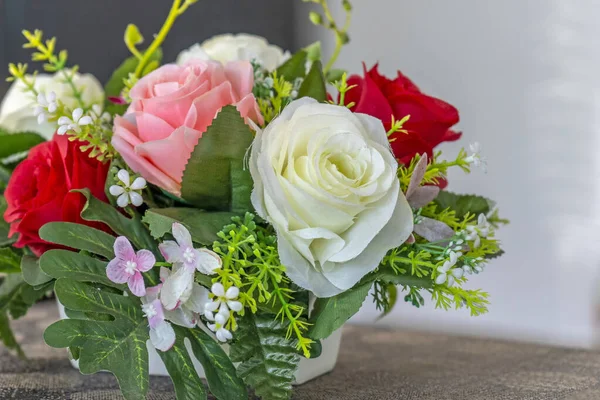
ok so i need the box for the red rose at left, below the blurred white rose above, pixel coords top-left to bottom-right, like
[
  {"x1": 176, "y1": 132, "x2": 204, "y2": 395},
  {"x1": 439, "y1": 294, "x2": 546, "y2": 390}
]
[{"x1": 4, "y1": 135, "x2": 109, "y2": 256}]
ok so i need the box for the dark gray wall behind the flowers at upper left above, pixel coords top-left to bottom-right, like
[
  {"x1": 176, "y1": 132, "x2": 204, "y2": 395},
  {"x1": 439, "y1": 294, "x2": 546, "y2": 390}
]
[{"x1": 0, "y1": 0, "x2": 299, "y2": 98}]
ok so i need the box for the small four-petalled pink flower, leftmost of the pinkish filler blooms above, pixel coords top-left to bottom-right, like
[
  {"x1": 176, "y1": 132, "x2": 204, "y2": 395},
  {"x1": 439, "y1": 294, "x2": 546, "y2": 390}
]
[{"x1": 106, "y1": 236, "x2": 156, "y2": 297}]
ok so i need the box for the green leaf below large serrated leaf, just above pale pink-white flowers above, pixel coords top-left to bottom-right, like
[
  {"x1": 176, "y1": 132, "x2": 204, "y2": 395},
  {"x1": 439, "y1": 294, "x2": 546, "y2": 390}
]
[{"x1": 143, "y1": 207, "x2": 238, "y2": 246}]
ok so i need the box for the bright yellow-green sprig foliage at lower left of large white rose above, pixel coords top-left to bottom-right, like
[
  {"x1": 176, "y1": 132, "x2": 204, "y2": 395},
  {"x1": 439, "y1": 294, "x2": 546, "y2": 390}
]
[{"x1": 213, "y1": 213, "x2": 313, "y2": 358}]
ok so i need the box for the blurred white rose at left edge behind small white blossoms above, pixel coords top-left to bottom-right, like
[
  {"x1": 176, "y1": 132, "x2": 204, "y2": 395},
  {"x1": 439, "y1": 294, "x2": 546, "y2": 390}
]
[{"x1": 0, "y1": 73, "x2": 104, "y2": 139}]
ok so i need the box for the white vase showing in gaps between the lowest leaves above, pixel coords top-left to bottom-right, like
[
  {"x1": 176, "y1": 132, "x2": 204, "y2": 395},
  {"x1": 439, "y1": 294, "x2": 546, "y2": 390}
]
[{"x1": 58, "y1": 303, "x2": 342, "y2": 385}]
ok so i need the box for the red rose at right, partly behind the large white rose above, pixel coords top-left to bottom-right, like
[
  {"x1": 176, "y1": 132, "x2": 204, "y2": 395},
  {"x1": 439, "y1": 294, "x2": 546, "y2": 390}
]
[{"x1": 346, "y1": 65, "x2": 461, "y2": 164}]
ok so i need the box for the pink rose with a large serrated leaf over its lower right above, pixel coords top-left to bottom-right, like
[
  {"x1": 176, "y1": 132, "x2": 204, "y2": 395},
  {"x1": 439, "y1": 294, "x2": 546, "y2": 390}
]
[{"x1": 112, "y1": 61, "x2": 263, "y2": 195}]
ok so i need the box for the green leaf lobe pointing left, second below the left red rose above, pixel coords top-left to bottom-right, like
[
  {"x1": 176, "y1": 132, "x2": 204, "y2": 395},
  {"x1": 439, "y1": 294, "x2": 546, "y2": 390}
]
[{"x1": 39, "y1": 250, "x2": 125, "y2": 291}]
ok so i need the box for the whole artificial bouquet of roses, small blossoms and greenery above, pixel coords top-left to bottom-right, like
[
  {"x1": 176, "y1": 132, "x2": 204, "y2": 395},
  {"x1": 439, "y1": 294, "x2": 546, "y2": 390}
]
[{"x1": 0, "y1": 0, "x2": 506, "y2": 400}]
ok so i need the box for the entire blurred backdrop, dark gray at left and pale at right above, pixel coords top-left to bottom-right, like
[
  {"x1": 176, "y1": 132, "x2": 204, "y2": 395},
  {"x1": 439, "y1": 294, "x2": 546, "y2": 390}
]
[{"x1": 0, "y1": 0, "x2": 600, "y2": 347}]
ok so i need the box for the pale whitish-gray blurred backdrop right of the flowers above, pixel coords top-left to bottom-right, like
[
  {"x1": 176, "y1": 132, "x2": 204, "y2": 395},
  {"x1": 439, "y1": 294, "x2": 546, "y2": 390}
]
[{"x1": 298, "y1": 0, "x2": 600, "y2": 347}]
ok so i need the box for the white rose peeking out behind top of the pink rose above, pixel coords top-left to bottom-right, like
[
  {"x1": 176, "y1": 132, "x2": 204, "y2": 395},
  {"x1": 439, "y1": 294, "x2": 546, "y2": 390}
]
[{"x1": 177, "y1": 34, "x2": 290, "y2": 71}]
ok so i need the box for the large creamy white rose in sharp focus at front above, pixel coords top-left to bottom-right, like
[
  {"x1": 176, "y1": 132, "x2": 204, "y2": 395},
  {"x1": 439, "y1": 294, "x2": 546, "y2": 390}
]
[{"x1": 250, "y1": 98, "x2": 413, "y2": 297}]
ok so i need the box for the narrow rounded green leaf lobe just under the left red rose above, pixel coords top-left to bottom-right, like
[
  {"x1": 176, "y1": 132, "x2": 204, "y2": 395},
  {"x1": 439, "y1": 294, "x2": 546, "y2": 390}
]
[{"x1": 40, "y1": 222, "x2": 115, "y2": 260}]
